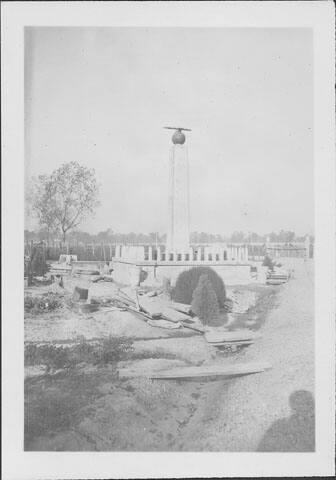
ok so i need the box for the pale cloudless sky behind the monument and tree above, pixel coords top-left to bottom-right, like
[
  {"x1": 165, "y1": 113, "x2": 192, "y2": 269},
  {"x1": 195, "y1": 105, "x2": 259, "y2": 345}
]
[{"x1": 25, "y1": 27, "x2": 314, "y2": 235}]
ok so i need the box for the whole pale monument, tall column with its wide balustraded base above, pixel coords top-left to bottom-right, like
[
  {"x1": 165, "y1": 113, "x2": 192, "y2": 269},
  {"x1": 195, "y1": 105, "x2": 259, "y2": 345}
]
[{"x1": 111, "y1": 127, "x2": 252, "y2": 286}]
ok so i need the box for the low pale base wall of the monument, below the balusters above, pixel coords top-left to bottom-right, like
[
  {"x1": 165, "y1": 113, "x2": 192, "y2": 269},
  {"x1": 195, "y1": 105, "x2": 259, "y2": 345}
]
[{"x1": 112, "y1": 260, "x2": 263, "y2": 286}]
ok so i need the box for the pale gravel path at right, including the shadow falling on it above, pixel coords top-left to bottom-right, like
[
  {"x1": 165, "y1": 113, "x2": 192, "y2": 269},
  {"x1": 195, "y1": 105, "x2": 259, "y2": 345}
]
[{"x1": 184, "y1": 262, "x2": 314, "y2": 451}]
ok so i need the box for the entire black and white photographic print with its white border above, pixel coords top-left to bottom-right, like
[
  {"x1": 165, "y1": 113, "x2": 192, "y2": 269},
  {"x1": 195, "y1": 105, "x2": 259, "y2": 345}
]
[{"x1": 3, "y1": 2, "x2": 335, "y2": 479}]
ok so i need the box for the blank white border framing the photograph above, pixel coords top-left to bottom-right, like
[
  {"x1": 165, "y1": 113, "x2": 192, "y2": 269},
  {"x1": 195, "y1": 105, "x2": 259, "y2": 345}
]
[{"x1": 1, "y1": 1, "x2": 336, "y2": 480}]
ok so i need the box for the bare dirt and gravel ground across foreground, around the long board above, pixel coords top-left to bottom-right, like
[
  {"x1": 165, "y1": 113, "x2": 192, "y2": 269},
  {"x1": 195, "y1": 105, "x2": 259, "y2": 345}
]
[{"x1": 25, "y1": 264, "x2": 314, "y2": 451}]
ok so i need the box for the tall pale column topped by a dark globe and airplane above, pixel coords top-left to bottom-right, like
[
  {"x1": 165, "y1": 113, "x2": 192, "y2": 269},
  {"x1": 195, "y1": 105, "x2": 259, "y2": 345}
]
[{"x1": 164, "y1": 127, "x2": 191, "y2": 253}]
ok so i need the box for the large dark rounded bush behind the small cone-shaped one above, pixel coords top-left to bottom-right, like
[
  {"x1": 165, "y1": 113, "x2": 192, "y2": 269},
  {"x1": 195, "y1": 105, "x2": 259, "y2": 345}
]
[{"x1": 172, "y1": 267, "x2": 226, "y2": 307}]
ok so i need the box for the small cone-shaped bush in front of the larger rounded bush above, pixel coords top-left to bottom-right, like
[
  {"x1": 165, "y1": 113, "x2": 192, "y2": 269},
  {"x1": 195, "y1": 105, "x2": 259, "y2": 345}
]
[{"x1": 191, "y1": 275, "x2": 219, "y2": 325}]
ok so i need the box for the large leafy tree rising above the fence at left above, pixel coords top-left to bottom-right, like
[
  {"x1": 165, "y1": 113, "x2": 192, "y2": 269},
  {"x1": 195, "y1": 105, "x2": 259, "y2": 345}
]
[{"x1": 33, "y1": 162, "x2": 99, "y2": 241}]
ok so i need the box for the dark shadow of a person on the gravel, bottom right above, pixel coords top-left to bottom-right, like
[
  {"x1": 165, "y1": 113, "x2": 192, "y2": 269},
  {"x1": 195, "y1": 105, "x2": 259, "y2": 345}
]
[{"x1": 257, "y1": 390, "x2": 315, "y2": 452}]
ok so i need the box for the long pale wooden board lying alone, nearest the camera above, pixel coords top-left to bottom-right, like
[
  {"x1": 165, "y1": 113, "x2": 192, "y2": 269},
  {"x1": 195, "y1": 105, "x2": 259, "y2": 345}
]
[{"x1": 119, "y1": 363, "x2": 272, "y2": 380}]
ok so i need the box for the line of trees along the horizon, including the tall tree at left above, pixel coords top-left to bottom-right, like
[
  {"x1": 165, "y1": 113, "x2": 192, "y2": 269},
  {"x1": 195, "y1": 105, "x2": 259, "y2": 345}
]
[{"x1": 25, "y1": 161, "x2": 313, "y2": 244}]
